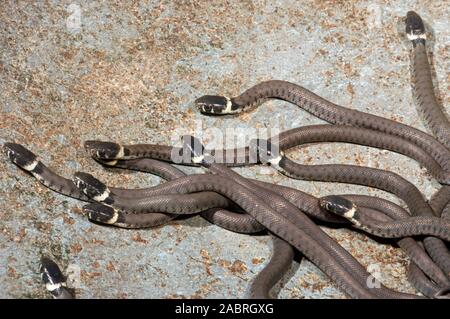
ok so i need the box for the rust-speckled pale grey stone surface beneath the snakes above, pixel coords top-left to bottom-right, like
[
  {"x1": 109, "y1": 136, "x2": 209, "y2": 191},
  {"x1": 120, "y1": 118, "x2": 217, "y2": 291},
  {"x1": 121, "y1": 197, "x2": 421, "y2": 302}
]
[{"x1": 0, "y1": 0, "x2": 450, "y2": 298}]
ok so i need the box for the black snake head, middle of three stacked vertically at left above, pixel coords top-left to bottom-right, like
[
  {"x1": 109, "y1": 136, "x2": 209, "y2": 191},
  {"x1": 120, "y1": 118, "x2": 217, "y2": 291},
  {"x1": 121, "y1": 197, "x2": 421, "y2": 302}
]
[{"x1": 73, "y1": 172, "x2": 114, "y2": 205}]
